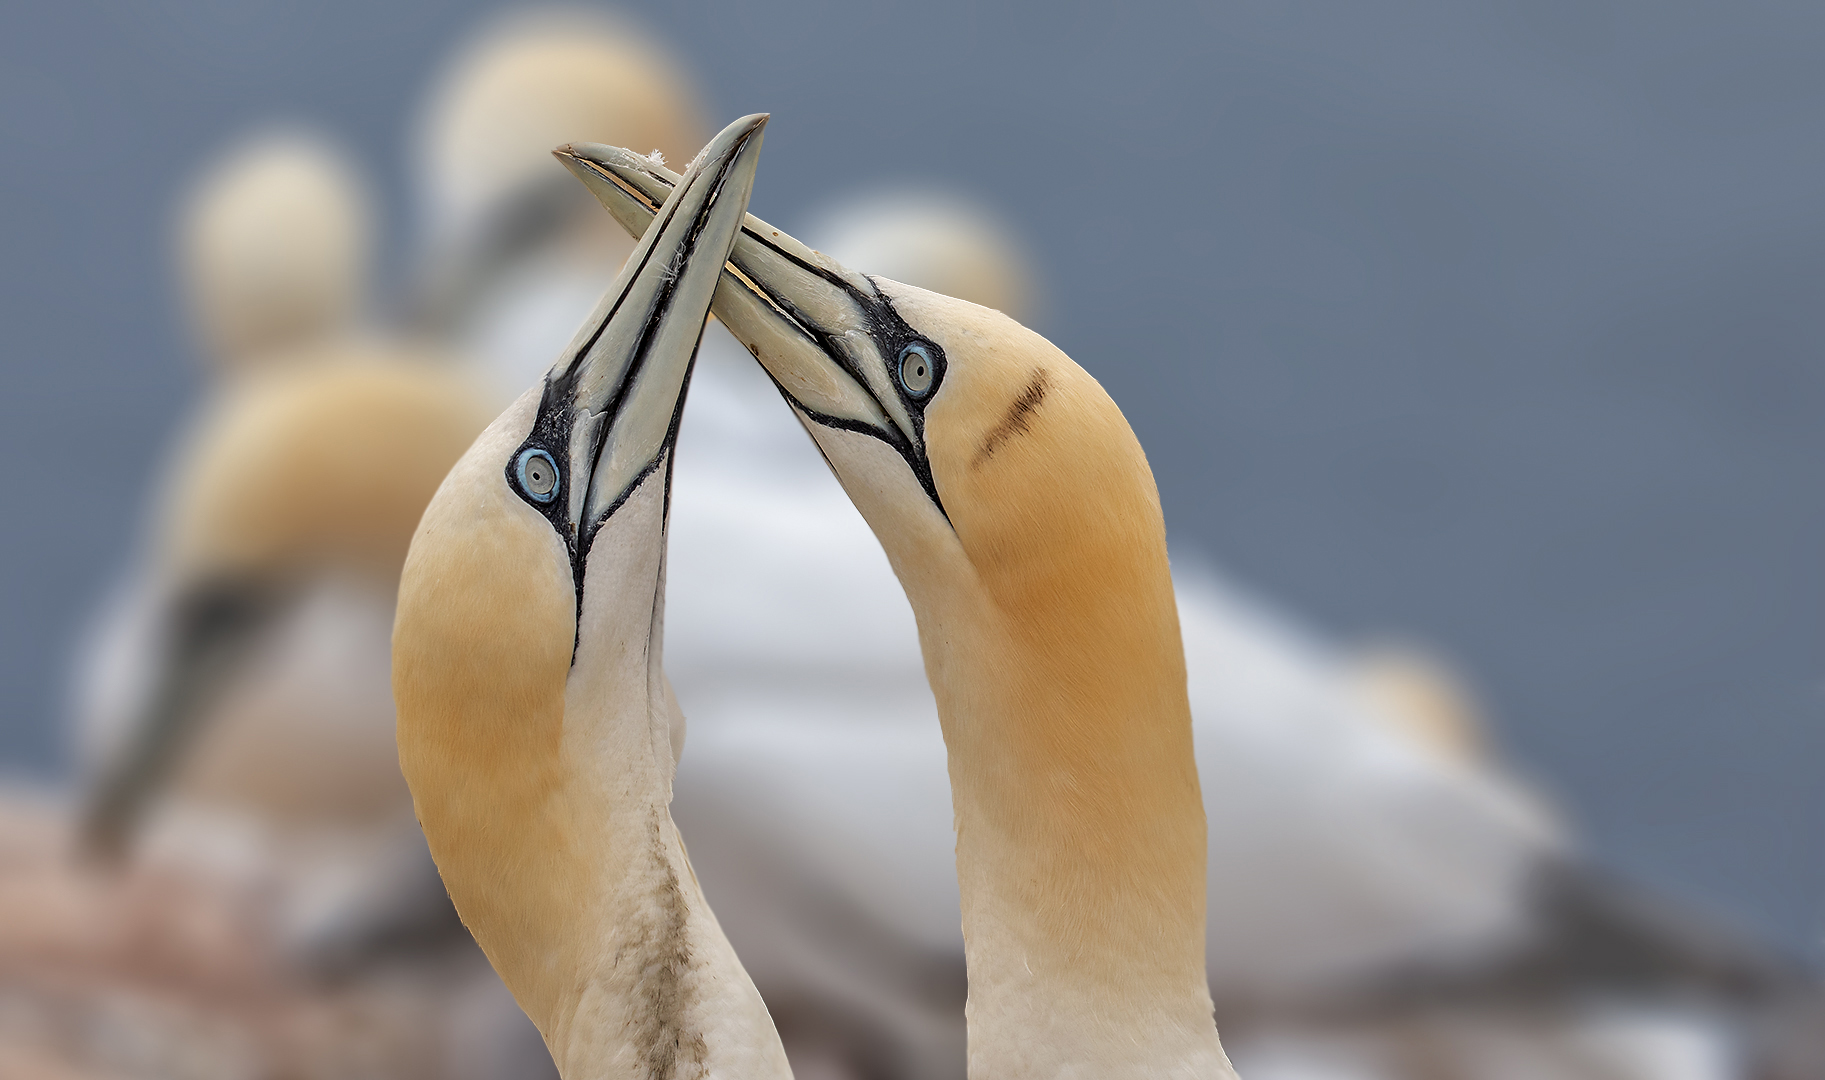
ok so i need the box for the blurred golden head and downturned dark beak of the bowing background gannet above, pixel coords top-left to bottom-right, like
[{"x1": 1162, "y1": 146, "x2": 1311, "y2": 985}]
[{"x1": 84, "y1": 348, "x2": 487, "y2": 854}]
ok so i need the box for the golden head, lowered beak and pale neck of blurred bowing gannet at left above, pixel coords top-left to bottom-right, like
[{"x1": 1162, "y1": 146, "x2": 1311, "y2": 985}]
[{"x1": 88, "y1": 356, "x2": 485, "y2": 868}]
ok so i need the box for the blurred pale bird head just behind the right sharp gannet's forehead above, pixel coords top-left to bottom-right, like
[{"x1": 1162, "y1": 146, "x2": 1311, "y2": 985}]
[{"x1": 801, "y1": 190, "x2": 1035, "y2": 323}]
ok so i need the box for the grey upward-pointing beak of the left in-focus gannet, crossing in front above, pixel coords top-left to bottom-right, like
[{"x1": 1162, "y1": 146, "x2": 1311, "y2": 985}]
[{"x1": 532, "y1": 113, "x2": 767, "y2": 561}]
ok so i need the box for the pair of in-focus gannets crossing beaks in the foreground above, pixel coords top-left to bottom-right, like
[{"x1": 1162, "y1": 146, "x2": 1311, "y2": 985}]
[{"x1": 394, "y1": 117, "x2": 1234, "y2": 1076}]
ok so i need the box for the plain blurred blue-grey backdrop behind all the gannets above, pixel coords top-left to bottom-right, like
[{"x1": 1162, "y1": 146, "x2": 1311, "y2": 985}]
[{"x1": 0, "y1": 0, "x2": 1825, "y2": 950}]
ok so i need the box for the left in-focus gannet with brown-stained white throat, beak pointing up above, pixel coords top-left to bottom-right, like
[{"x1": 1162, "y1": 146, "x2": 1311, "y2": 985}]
[{"x1": 394, "y1": 115, "x2": 790, "y2": 1078}]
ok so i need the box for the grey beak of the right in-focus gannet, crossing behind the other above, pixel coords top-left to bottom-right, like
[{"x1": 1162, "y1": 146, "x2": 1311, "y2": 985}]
[{"x1": 557, "y1": 142, "x2": 942, "y2": 502}]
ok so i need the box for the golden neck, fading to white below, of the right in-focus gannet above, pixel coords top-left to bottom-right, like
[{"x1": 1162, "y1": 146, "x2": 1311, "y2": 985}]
[{"x1": 916, "y1": 538, "x2": 1234, "y2": 1080}]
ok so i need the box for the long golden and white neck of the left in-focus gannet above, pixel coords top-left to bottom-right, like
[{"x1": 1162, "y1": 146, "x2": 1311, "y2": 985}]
[{"x1": 394, "y1": 481, "x2": 790, "y2": 1080}]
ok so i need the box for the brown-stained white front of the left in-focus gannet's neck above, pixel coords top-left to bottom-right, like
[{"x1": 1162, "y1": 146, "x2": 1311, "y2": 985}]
[{"x1": 546, "y1": 474, "x2": 790, "y2": 1080}]
